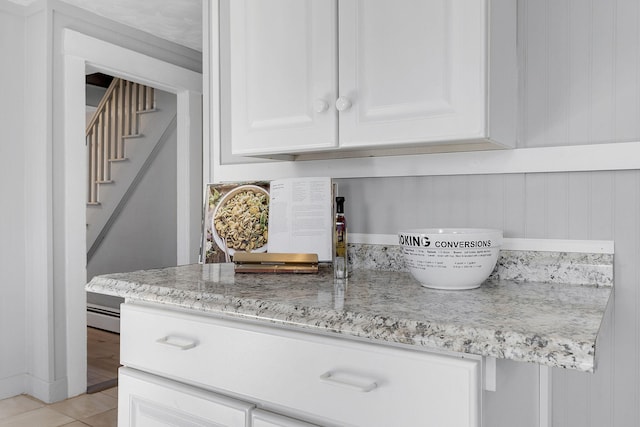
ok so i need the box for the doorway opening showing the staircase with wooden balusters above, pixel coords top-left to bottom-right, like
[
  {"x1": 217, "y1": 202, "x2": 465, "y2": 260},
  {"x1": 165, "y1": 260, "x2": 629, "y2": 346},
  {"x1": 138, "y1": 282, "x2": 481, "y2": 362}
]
[{"x1": 85, "y1": 73, "x2": 177, "y2": 392}]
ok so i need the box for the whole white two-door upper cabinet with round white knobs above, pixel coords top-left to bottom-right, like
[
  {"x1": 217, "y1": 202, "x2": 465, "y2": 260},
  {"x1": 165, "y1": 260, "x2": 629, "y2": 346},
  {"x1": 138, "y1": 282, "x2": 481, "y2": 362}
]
[{"x1": 221, "y1": 0, "x2": 517, "y2": 159}]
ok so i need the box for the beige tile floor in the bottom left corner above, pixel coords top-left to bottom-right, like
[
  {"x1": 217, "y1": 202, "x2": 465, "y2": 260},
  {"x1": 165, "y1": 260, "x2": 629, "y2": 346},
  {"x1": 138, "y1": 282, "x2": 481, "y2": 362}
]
[{"x1": 0, "y1": 387, "x2": 118, "y2": 427}]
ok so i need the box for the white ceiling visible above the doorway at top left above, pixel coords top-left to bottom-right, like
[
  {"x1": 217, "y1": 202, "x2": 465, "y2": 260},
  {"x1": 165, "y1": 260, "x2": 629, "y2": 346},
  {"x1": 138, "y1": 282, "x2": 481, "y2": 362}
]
[{"x1": 5, "y1": 0, "x2": 203, "y2": 52}]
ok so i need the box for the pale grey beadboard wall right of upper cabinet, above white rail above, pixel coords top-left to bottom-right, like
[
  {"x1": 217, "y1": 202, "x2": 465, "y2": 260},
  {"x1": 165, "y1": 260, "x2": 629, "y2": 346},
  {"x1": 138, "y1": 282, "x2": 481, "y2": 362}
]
[{"x1": 518, "y1": 0, "x2": 640, "y2": 147}]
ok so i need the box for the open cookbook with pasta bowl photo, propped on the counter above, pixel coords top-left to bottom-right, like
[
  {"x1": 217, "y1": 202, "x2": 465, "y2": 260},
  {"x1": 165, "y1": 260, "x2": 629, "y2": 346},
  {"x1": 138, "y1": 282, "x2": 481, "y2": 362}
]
[{"x1": 202, "y1": 177, "x2": 335, "y2": 263}]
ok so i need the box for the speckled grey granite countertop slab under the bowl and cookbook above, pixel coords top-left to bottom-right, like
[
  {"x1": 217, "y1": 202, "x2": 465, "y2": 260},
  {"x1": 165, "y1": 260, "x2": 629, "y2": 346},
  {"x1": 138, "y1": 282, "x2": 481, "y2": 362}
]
[{"x1": 86, "y1": 249, "x2": 613, "y2": 372}]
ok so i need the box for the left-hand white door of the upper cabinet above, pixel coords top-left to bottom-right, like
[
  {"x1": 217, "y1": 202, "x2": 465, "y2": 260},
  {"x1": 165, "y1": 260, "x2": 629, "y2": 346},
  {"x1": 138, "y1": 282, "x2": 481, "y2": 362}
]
[{"x1": 229, "y1": 0, "x2": 338, "y2": 155}]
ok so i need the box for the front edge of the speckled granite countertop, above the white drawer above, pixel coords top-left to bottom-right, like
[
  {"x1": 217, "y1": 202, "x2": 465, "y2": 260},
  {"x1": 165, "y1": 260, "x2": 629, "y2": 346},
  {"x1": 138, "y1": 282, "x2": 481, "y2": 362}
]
[{"x1": 87, "y1": 276, "x2": 608, "y2": 372}]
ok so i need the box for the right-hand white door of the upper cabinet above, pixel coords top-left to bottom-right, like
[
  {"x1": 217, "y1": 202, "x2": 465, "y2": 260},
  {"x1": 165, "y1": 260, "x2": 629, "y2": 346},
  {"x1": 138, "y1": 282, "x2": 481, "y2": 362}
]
[{"x1": 338, "y1": 0, "x2": 487, "y2": 148}]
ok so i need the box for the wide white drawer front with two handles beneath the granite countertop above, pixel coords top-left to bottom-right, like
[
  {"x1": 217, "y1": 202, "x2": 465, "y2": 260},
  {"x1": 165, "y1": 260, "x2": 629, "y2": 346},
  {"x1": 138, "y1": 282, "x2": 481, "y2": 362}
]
[{"x1": 120, "y1": 304, "x2": 480, "y2": 427}]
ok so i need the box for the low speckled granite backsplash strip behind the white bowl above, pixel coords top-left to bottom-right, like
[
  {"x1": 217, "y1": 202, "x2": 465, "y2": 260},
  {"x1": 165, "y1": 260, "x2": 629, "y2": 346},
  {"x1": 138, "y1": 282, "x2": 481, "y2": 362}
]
[{"x1": 349, "y1": 244, "x2": 613, "y2": 287}]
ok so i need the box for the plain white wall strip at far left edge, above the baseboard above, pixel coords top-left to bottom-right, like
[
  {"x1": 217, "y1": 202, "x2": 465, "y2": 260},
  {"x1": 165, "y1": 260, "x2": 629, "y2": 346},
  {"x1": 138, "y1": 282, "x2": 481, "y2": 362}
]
[{"x1": 0, "y1": 3, "x2": 27, "y2": 399}]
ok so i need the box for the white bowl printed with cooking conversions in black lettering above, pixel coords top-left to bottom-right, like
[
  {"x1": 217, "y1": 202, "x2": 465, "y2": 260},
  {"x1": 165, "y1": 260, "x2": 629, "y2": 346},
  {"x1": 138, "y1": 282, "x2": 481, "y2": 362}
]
[{"x1": 398, "y1": 228, "x2": 502, "y2": 289}]
